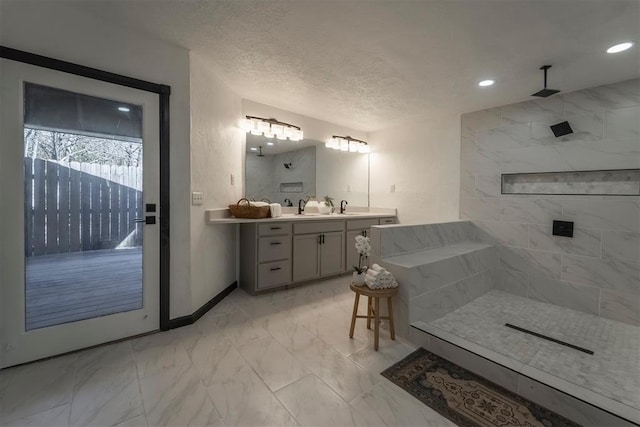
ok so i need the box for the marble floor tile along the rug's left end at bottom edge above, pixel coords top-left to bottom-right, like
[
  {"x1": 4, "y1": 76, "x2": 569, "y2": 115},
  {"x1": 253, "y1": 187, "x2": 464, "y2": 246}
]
[{"x1": 351, "y1": 379, "x2": 456, "y2": 427}]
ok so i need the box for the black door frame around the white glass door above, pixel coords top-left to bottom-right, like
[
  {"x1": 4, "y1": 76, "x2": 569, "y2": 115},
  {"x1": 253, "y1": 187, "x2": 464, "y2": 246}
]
[{"x1": 0, "y1": 46, "x2": 171, "y2": 331}]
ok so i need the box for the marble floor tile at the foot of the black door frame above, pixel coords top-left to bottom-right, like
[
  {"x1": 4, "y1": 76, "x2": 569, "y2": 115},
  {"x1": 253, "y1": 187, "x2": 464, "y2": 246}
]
[{"x1": 132, "y1": 329, "x2": 191, "y2": 378}]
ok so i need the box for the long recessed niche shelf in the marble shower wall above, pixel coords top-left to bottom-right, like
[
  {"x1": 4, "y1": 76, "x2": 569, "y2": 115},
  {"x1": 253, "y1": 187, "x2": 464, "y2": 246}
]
[{"x1": 501, "y1": 169, "x2": 640, "y2": 196}]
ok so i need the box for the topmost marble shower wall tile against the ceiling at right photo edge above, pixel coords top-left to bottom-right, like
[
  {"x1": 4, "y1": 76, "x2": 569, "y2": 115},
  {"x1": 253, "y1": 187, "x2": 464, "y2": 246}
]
[{"x1": 564, "y1": 79, "x2": 640, "y2": 115}]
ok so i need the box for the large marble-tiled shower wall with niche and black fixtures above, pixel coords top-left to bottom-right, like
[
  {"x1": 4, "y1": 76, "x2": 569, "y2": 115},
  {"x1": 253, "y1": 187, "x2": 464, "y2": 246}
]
[{"x1": 460, "y1": 79, "x2": 640, "y2": 325}]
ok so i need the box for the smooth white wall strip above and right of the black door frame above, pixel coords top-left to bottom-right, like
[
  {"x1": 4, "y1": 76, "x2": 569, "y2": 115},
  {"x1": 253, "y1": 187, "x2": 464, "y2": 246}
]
[{"x1": 0, "y1": 2, "x2": 192, "y2": 318}]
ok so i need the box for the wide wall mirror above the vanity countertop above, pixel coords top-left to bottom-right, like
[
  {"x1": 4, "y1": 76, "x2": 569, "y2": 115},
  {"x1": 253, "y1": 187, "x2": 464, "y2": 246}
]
[{"x1": 245, "y1": 134, "x2": 369, "y2": 206}]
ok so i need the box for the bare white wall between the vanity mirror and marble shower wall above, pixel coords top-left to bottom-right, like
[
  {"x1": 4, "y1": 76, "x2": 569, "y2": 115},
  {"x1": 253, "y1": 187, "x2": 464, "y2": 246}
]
[{"x1": 369, "y1": 114, "x2": 460, "y2": 224}]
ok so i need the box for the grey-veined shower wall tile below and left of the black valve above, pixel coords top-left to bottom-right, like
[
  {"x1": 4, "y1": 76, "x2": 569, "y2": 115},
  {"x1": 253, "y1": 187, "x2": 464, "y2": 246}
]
[{"x1": 499, "y1": 246, "x2": 560, "y2": 278}]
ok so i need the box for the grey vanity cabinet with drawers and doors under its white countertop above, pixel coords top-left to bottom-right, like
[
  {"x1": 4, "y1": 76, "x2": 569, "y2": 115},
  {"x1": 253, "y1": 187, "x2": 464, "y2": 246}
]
[{"x1": 232, "y1": 213, "x2": 396, "y2": 295}]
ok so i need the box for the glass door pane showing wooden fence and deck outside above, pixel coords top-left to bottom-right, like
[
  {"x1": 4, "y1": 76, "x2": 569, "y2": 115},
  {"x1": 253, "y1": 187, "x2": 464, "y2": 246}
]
[{"x1": 24, "y1": 83, "x2": 143, "y2": 330}]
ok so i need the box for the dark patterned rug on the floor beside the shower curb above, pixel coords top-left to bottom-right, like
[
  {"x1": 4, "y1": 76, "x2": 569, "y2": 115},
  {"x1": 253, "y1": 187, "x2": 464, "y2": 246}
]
[{"x1": 382, "y1": 348, "x2": 578, "y2": 427}]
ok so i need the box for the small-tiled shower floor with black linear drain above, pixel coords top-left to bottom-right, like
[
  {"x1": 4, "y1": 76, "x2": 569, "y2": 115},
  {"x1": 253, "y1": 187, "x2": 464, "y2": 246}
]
[{"x1": 429, "y1": 290, "x2": 640, "y2": 418}]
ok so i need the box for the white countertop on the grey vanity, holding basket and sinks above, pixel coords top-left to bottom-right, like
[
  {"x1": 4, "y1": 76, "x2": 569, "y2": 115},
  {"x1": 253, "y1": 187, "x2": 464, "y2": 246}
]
[{"x1": 205, "y1": 208, "x2": 396, "y2": 224}]
